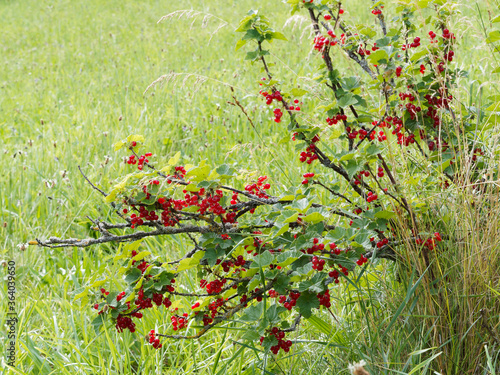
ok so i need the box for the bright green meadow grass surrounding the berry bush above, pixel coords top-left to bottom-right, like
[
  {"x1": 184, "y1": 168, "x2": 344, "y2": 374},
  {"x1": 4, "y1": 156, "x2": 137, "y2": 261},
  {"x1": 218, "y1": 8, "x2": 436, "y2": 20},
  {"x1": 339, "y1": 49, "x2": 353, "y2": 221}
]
[{"x1": 0, "y1": 0, "x2": 499, "y2": 374}]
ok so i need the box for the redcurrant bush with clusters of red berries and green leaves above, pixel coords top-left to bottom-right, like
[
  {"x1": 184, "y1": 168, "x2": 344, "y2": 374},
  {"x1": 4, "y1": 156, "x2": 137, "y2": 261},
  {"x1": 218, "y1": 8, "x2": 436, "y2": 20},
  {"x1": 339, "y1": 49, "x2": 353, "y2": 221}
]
[{"x1": 38, "y1": 0, "x2": 496, "y2": 368}]
